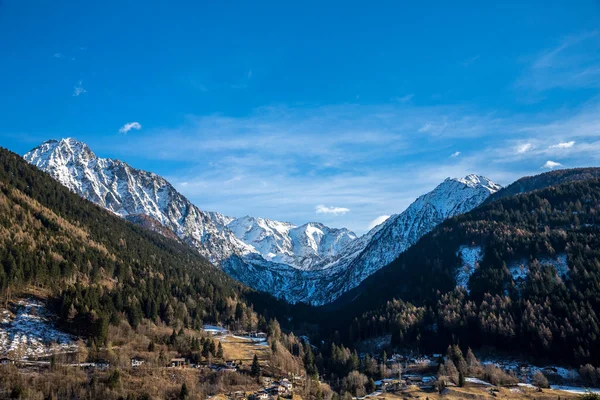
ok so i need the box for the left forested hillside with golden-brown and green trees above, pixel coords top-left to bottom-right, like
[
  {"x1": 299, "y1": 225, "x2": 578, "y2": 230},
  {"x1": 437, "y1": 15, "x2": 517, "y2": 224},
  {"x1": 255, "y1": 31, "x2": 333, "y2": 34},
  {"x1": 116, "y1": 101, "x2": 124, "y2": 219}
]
[{"x1": 0, "y1": 149, "x2": 271, "y2": 342}]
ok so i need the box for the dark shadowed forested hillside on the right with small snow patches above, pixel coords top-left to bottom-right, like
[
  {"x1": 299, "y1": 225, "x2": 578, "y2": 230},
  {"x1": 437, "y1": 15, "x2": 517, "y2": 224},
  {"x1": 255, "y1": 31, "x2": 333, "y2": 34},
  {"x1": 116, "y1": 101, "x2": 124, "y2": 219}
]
[{"x1": 327, "y1": 177, "x2": 600, "y2": 365}]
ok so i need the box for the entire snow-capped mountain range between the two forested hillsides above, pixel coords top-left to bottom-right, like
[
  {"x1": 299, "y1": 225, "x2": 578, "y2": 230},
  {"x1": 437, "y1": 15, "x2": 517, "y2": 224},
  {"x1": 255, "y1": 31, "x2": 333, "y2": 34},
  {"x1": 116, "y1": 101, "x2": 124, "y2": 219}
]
[{"x1": 24, "y1": 138, "x2": 501, "y2": 305}]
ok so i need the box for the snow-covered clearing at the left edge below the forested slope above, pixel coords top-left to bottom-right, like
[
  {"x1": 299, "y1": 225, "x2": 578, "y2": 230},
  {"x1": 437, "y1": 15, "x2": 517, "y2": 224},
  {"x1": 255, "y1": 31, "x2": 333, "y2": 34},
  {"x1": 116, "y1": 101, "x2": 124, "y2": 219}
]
[{"x1": 0, "y1": 299, "x2": 77, "y2": 359}]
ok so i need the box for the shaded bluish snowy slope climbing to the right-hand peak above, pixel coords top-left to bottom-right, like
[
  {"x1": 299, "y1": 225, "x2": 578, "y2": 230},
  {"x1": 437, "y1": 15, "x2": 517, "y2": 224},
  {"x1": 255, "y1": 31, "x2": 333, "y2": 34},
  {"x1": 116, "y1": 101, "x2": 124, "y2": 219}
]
[{"x1": 220, "y1": 175, "x2": 501, "y2": 305}]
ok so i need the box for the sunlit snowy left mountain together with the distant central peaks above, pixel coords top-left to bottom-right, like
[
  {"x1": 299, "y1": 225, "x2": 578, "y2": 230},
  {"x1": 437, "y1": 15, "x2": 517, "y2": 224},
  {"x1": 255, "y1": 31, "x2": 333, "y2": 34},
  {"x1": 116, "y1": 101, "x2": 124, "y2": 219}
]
[{"x1": 24, "y1": 138, "x2": 356, "y2": 269}]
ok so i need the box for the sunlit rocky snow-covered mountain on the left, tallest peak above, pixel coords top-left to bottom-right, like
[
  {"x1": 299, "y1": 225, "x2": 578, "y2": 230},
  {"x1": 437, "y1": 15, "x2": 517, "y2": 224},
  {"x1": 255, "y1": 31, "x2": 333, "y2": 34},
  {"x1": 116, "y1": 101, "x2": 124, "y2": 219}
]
[{"x1": 24, "y1": 138, "x2": 254, "y2": 263}]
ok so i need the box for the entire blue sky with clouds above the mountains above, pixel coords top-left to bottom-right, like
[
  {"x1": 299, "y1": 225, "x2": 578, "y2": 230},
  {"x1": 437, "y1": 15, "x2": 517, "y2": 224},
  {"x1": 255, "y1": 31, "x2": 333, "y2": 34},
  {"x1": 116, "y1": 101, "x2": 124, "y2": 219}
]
[{"x1": 0, "y1": 0, "x2": 600, "y2": 233}]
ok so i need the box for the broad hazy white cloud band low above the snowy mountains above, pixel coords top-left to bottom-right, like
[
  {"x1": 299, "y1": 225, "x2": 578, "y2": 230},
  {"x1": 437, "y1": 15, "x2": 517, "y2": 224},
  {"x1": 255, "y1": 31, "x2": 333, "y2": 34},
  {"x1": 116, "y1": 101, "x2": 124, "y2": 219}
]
[{"x1": 101, "y1": 104, "x2": 600, "y2": 234}]
